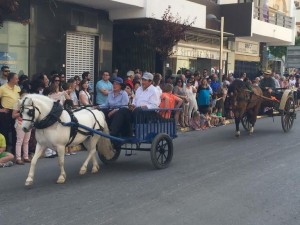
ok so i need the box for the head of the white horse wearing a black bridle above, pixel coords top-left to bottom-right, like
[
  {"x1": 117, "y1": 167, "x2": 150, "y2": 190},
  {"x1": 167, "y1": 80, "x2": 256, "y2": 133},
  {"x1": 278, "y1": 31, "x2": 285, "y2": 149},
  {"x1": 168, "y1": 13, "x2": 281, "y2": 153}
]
[{"x1": 19, "y1": 95, "x2": 41, "y2": 132}]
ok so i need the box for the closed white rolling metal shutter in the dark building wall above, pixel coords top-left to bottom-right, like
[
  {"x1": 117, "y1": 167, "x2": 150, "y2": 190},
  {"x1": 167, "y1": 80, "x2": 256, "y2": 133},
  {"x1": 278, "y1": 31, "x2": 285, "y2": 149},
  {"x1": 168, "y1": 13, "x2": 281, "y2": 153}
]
[{"x1": 66, "y1": 33, "x2": 95, "y2": 87}]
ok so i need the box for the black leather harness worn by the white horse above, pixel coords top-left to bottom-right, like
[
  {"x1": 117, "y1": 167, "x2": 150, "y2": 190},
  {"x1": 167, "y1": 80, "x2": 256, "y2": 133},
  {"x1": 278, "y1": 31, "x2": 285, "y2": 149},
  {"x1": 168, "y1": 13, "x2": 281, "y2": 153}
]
[{"x1": 20, "y1": 97, "x2": 104, "y2": 146}]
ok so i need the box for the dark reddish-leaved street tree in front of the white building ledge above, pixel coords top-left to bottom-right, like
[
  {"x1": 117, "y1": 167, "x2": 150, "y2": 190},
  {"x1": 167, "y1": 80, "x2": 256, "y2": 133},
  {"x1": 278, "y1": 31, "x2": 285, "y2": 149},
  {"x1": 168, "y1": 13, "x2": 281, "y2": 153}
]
[{"x1": 136, "y1": 5, "x2": 196, "y2": 69}]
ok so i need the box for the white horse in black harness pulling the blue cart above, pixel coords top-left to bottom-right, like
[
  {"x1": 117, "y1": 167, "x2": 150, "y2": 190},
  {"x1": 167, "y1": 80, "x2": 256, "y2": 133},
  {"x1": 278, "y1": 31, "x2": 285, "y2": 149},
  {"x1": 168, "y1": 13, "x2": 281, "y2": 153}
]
[{"x1": 19, "y1": 94, "x2": 114, "y2": 186}]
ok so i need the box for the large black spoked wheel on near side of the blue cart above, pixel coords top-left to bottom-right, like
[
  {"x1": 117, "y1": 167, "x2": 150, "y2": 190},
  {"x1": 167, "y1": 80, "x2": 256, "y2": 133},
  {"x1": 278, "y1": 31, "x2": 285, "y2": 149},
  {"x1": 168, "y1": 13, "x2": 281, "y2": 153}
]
[{"x1": 150, "y1": 134, "x2": 173, "y2": 169}]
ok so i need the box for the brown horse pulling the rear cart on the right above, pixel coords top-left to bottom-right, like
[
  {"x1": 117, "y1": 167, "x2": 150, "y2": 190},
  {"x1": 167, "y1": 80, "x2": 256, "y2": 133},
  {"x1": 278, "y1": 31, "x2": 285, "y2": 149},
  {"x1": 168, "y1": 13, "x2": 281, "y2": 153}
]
[{"x1": 228, "y1": 80, "x2": 263, "y2": 137}]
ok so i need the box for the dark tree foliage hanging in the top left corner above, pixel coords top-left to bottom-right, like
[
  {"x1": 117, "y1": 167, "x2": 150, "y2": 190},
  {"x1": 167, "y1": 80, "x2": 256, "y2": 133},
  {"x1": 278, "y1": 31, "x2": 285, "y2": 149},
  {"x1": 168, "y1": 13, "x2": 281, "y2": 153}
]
[{"x1": 0, "y1": 0, "x2": 30, "y2": 26}]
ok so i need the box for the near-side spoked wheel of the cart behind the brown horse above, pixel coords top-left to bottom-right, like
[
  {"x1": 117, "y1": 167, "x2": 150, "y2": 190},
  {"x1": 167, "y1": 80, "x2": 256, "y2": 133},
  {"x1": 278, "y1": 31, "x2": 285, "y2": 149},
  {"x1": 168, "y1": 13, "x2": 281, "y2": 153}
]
[{"x1": 281, "y1": 96, "x2": 296, "y2": 132}]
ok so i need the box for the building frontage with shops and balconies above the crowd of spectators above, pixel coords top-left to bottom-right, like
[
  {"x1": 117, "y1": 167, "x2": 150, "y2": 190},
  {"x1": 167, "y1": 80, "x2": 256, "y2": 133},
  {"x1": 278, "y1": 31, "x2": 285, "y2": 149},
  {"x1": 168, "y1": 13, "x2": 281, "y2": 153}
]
[{"x1": 0, "y1": 0, "x2": 296, "y2": 80}]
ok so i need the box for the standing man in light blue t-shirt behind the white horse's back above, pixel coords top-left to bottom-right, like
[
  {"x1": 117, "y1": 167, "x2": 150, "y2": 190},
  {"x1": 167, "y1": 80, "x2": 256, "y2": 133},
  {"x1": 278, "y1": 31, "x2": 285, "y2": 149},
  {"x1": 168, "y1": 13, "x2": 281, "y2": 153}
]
[{"x1": 96, "y1": 71, "x2": 112, "y2": 105}]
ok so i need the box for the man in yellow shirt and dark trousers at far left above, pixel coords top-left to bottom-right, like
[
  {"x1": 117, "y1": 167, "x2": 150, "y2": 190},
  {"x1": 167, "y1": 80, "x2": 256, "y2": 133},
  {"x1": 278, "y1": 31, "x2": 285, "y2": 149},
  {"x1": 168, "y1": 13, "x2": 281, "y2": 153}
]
[{"x1": 0, "y1": 73, "x2": 21, "y2": 154}]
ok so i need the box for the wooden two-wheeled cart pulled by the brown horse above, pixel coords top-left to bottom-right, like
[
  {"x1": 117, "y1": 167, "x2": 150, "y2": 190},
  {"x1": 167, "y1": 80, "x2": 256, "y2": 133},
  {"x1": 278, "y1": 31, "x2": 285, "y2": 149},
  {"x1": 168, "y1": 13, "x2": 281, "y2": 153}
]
[{"x1": 241, "y1": 88, "x2": 297, "y2": 132}]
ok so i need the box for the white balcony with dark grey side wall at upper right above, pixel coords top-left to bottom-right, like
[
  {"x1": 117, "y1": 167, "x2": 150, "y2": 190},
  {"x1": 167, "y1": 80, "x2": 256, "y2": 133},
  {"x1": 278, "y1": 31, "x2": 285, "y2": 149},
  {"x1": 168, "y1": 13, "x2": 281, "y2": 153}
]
[{"x1": 221, "y1": 2, "x2": 295, "y2": 46}]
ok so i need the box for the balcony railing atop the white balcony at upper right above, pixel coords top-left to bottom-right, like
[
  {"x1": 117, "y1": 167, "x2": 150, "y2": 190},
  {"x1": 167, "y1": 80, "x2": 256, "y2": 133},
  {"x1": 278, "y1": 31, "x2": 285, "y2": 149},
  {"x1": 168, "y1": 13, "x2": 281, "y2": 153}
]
[{"x1": 254, "y1": 7, "x2": 293, "y2": 29}]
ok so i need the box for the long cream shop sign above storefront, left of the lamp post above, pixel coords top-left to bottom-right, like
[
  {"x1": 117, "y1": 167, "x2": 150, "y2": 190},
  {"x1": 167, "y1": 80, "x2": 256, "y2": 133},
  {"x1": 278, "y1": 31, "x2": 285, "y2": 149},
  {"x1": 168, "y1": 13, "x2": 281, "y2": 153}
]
[{"x1": 174, "y1": 46, "x2": 227, "y2": 60}]
